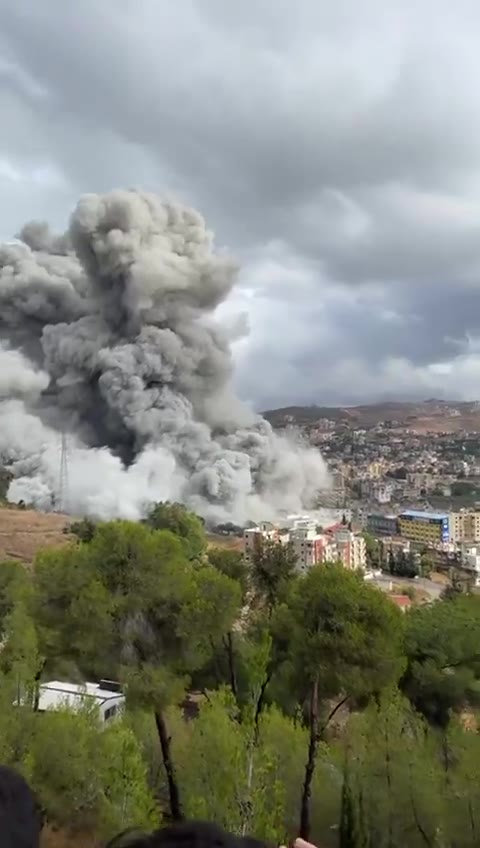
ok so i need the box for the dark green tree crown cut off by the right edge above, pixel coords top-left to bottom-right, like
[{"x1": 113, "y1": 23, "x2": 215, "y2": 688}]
[{"x1": 401, "y1": 595, "x2": 480, "y2": 727}]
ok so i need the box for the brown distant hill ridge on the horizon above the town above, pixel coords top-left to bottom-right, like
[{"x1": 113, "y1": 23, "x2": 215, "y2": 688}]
[{"x1": 263, "y1": 399, "x2": 480, "y2": 433}]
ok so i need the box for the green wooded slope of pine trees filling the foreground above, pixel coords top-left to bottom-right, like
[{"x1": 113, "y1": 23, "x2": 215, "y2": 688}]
[{"x1": 0, "y1": 504, "x2": 480, "y2": 848}]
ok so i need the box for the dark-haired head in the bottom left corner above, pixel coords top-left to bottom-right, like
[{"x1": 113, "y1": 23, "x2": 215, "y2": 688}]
[{"x1": 0, "y1": 766, "x2": 42, "y2": 848}]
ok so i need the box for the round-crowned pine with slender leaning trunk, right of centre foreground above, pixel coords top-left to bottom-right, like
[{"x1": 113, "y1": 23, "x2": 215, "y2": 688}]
[{"x1": 277, "y1": 565, "x2": 403, "y2": 839}]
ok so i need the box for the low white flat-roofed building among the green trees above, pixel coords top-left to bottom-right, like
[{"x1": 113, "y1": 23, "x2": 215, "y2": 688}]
[{"x1": 37, "y1": 680, "x2": 125, "y2": 724}]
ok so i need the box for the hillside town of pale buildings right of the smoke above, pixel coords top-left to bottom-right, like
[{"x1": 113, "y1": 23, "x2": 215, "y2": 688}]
[{"x1": 251, "y1": 401, "x2": 480, "y2": 596}]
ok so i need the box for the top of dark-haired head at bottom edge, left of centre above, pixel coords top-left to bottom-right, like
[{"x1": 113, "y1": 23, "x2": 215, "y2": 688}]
[{"x1": 107, "y1": 821, "x2": 267, "y2": 848}]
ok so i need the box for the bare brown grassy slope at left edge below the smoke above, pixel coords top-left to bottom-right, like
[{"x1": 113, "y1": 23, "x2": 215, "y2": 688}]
[{"x1": 0, "y1": 507, "x2": 73, "y2": 563}]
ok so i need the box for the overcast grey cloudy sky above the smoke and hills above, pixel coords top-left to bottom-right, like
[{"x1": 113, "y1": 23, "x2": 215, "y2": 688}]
[{"x1": 0, "y1": 0, "x2": 480, "y2": 408}]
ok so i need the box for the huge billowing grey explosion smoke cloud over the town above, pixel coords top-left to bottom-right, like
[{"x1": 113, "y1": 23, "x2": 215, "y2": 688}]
[{"x1": 0, "y1": 191, "x2": 327, "y2": 523}]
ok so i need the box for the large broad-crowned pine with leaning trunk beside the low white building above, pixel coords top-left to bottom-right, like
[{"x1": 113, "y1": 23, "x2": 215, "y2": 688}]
[{"x1": 35, "y1": 521, "x2": 241, "y2": 819}]
